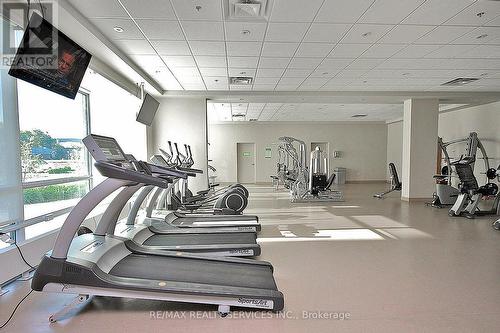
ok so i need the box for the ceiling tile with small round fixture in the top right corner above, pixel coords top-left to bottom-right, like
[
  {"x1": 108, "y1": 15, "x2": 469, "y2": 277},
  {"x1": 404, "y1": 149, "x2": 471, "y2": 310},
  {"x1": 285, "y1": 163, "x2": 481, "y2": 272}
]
[{"x1": 444, "y1": 1, "x2": 500, "y2": 26}]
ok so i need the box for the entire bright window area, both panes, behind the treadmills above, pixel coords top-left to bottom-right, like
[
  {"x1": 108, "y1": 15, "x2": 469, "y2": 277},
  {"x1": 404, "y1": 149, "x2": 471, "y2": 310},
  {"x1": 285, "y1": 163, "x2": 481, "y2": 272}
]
[{"x1": 12, "y1": 70, "x2": 147, "y2": 240}]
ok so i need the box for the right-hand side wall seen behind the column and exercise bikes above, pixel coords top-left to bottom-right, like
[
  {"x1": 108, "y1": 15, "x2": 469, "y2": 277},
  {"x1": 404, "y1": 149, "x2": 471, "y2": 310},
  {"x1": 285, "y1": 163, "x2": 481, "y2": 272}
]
[{"x1": 387, "y1": 102, "x2": 500, "y2": 183}]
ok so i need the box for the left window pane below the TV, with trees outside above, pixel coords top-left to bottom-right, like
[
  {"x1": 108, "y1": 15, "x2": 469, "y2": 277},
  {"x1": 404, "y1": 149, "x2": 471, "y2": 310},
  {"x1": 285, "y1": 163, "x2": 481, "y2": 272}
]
[{"x1": 17, "y1": 80, "x2": 91, "y2": 239}]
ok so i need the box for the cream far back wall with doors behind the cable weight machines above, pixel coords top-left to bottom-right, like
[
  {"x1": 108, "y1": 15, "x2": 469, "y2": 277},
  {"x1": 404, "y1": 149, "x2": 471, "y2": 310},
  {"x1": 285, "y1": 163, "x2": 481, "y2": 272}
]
[{"x1": 209, "y1": 122, "x2": 387, "y2": 182}]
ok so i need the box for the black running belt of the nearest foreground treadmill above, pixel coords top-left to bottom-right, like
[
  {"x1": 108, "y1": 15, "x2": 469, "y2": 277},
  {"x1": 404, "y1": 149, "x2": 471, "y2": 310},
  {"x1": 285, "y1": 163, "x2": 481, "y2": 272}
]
[{"x1": 109, "y1": 254, "x2": 277, "y2": 290}]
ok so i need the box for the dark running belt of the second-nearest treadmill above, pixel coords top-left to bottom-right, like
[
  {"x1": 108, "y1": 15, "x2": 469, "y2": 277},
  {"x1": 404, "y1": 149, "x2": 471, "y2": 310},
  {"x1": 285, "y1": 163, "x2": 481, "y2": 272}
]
[{"x1": 143, "y1": 232, "x2": 257, "y2": 246}]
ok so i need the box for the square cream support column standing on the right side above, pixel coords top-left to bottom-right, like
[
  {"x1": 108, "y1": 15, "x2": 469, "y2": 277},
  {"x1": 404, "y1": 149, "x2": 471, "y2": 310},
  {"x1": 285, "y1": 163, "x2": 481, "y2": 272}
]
[{"x1": 401, "y1": 99, "x2": 439, "y2": 201}]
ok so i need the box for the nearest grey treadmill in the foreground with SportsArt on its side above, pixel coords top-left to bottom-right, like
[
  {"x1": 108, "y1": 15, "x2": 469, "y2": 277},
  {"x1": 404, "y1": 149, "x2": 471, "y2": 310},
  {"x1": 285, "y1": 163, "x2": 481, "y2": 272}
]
[{"x1": 31, "y1": 133, "x2": 284, "y2": 322}]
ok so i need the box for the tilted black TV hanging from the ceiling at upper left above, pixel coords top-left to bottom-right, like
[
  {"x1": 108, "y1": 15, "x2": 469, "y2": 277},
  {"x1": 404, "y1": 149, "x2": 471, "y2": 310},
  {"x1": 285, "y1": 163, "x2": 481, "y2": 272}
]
[{"x1": 9, "y1": 13, "x2": 92, "y2": 99}]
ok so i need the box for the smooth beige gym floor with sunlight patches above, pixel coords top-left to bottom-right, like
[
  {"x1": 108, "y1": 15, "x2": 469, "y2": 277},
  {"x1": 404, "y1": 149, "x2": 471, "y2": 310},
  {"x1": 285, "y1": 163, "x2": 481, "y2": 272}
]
[{"x1": 0, "y1": 184, "x2": 500, "y2": 333}]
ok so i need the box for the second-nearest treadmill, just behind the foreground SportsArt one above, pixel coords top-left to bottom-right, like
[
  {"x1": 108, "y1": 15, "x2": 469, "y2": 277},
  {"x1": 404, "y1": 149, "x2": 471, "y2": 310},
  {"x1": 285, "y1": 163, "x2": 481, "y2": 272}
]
[{"x1": 83, "y1": 134, "x2": 261, "y2": 257}]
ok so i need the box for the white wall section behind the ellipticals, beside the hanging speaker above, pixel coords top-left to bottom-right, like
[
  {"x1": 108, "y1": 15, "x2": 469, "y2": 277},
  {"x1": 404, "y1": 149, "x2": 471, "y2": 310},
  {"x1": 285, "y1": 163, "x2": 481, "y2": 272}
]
[{"x1": 148, "y1": 97, "x2": 208, "y2": 190}]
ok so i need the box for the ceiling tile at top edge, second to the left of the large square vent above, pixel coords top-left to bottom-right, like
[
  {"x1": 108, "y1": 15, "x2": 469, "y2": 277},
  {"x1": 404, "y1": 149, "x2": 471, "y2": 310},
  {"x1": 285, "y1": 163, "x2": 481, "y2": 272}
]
[{"x1": 120, "y1": 0, "x2": 177, "y2": 21}]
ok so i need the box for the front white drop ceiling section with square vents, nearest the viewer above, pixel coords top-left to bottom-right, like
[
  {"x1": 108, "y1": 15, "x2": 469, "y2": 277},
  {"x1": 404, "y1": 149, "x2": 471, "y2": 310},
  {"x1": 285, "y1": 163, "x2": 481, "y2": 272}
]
[{"x1": 68, "y1": 0, "x2": 500, "y2": 92}]
